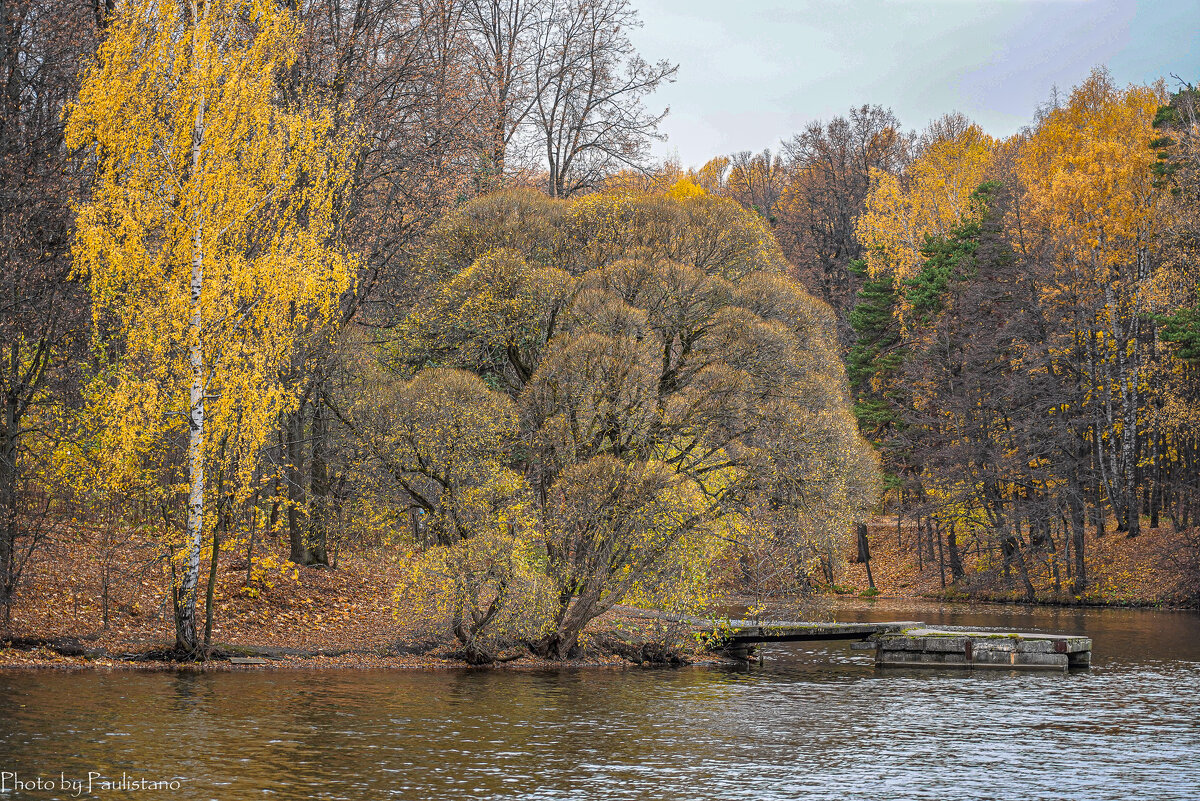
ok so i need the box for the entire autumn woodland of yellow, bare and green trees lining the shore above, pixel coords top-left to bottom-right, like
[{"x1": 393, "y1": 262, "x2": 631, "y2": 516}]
[{"x1": 0, "y1": 0, "x2": 1200, "y2": 663}]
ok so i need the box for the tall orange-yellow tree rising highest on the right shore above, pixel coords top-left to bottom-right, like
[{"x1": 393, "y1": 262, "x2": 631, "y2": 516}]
[{"x1": 1018, "y1": 71, "x2": 1165, "y2": 536}]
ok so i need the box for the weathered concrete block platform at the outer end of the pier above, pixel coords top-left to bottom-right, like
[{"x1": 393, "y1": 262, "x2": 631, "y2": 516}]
[{"x1": 871, "y1": 628, "x2": 1092, "y2": 670}]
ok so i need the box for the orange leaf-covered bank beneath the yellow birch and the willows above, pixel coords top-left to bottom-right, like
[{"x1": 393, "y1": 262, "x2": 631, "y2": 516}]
[{"x1": 0, "y1": 541, "x2": 719, "y2": 670}]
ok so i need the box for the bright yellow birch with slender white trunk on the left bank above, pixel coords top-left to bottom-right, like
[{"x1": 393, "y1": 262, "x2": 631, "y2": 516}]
[{"x1": 67, "y1": 0, "x2": 353, "y2": 652}]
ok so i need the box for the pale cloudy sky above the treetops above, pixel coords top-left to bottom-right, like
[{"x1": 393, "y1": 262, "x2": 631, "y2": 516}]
[{"x1": 630, "y1": 0, "x2": 1200, "y2": 167}]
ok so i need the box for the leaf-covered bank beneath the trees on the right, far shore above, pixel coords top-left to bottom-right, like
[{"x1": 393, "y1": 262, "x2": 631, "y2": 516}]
[{"x1": 836, "y1": 517, "x2": 1200, "y2": 609}]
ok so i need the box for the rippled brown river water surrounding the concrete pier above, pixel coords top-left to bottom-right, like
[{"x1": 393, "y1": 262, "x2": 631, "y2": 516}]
[{"x1": 0, "y1": 602, "x2": 1200, "y2": 801}]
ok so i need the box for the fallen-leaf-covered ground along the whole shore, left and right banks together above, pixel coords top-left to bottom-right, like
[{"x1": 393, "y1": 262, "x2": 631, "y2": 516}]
[{"x1": 0, "y1": 518, "x2": 1198, "y2": 670}]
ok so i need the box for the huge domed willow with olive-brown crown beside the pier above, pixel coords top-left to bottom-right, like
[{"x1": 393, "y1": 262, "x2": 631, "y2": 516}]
[{"x1": 350, "y1": 192, "x2": 877, "y2": 657}]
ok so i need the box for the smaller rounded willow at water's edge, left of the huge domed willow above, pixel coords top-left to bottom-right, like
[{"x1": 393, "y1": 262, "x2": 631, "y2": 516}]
[{"x1": 337, "y1": 368, "x2": 546, "y2": 664}]
